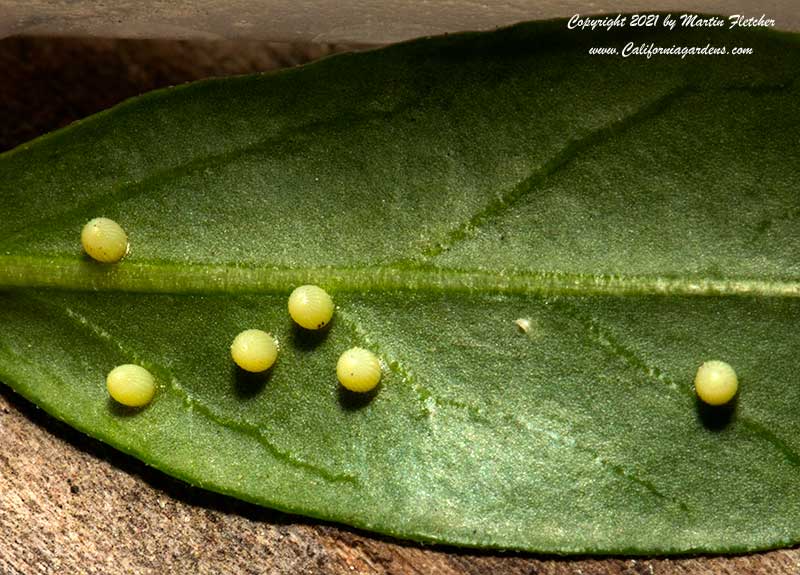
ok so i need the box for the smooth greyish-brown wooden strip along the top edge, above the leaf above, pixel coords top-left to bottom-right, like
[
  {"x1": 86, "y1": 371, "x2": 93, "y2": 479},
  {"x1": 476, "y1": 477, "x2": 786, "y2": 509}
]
[{"x1": 0, "y1": 0, "x2": 800, "y2": 44}]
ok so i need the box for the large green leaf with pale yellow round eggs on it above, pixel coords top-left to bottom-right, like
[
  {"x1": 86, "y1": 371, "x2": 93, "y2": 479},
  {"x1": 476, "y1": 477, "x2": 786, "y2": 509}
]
[{"x1": 0, "y1": 22, "x2": 800, "y2": 553}]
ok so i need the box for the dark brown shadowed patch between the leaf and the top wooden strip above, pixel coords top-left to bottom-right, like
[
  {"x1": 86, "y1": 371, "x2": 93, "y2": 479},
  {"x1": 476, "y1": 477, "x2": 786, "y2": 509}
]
[{"x1": 0, "y1": 36, "x2": 360, "y2": 152}]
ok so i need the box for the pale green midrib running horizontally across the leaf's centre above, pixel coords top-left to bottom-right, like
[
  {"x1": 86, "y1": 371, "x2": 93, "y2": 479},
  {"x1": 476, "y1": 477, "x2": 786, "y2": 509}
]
[{"x1": 0, "y1": 256, "x2": 800, "y2": 298}]
